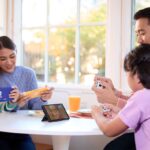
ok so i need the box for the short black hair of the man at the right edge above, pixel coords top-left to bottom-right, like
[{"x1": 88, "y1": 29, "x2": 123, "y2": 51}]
[{"x1": 134, "y1": 7, "x2": 150, "y2": 23}]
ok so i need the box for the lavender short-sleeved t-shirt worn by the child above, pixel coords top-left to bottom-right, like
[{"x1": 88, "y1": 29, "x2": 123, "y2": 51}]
[{"x1": 119, "y1": 89, "x2": 150, "y2": 150}]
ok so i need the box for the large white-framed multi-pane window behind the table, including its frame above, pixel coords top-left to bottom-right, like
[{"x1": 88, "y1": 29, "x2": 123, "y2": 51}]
[{"x1": 10, "y1": 0, "x2": 133, "y2": 89}]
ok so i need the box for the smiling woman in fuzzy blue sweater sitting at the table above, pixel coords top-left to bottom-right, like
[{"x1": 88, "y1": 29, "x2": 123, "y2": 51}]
[{"x1": 0, "y1": 36, "x2": 53, "y2": 150}]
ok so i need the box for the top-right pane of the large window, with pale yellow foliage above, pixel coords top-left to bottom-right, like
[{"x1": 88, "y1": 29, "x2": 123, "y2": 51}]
[{"x1": 80, "y1": 0, "x2": 107, "y2": 23}]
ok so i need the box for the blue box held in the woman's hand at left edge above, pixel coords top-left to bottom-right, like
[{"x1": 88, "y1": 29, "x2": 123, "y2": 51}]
[{"x1": 0, "y1": 87, "x2": 13, "y2": 102}]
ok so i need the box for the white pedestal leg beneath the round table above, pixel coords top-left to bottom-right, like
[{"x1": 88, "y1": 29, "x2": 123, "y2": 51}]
[{"x1": 52, "y1": 136, "x2": 70, "y2": 150}]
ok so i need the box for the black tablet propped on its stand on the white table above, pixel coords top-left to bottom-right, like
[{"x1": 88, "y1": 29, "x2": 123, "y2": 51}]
[{"x1": 42, "y1": 104, "x2": 70, "y2": 122}]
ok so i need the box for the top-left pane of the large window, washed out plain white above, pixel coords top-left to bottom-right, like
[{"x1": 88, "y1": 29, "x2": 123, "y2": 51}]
[{"x1": 22, "y1": 0, "x2": 47, "y2": 27}]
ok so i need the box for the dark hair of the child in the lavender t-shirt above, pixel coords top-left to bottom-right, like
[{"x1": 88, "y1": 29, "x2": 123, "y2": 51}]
[{"x1": 124, "y1": 44, "x2": 150, "y2": 89}]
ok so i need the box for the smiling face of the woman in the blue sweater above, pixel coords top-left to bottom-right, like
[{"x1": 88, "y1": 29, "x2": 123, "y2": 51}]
[{"x1": 0, "y1": 48, "x2": 16, "y2": 73}]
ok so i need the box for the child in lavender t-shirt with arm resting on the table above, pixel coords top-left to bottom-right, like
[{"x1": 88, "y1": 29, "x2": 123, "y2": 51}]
[{"x1": 92, "y1": 44, "x2": 150, "y2": 150}]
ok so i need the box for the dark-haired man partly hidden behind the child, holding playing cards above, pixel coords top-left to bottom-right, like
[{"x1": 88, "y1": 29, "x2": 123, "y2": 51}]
[{"x1": 92, "y1": 7, "x2": 150, "y2": 150}]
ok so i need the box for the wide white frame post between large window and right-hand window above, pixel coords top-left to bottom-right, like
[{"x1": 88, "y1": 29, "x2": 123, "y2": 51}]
[{"x1": 106, "y1": 0, "x2": 132, "y2": 90}]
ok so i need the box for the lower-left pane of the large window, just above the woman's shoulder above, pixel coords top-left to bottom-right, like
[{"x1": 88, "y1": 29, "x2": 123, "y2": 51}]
[{"x1": 23, "y1": 29, "x2": 45, "y2": 81}]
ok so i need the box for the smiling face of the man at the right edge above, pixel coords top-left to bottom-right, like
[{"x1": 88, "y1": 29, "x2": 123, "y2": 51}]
[{"x1": 135, "y1": 18, "x2": 150, "y2": 44}]
